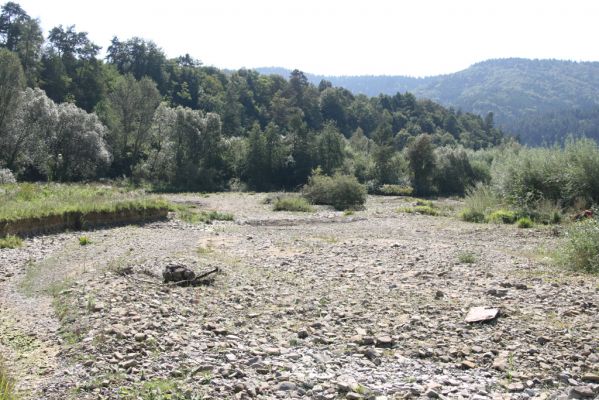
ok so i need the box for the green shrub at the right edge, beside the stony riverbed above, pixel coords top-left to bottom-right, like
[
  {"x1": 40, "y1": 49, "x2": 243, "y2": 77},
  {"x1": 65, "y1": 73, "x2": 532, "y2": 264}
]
[{"x1": 556, "y1": 218, "x2": 599, "y2": 273}]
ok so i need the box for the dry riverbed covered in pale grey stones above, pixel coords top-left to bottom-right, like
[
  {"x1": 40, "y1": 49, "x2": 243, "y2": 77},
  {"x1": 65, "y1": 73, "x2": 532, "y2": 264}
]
[{"x1": 0, "y1": 194, "x2": 599, "y2": 400}]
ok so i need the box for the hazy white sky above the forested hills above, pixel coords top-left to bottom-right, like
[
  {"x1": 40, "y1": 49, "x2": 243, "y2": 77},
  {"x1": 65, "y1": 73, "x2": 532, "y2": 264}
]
[{"x1": 15, "y1": 0, "x2": 599, "y2": 76}]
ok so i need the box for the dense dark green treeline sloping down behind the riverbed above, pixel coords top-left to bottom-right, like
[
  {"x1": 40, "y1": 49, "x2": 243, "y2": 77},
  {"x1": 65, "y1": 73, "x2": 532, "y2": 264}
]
[{"x1": 0, "y1": 2, "x2": 504, "y2": 193}]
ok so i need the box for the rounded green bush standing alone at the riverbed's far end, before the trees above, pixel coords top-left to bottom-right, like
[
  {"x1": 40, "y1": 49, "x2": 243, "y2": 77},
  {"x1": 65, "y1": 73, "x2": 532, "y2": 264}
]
[{"x1": 303, "y1": 174, "x2": 366, "y2": 210}]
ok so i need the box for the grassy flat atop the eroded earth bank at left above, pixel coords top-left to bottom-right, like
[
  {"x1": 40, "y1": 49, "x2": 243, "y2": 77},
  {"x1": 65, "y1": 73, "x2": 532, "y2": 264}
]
[{"x1": 0, "y1": 183, "x2": 168, "y2": 222}]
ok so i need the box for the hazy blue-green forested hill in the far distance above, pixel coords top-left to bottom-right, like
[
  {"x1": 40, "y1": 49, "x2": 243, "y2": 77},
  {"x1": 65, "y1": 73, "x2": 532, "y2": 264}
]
[{"x1": 258, "y1": 58, "x2": 599, "y2": 144}]
